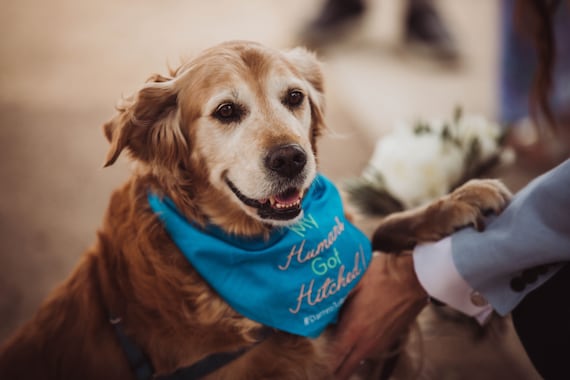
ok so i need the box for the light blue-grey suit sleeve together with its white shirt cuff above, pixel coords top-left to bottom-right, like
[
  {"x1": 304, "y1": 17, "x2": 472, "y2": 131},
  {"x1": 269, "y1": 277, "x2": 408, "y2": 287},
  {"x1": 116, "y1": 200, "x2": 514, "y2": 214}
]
[{"x1": 414, "y1": 160, "x2": 570, "y2": 323}]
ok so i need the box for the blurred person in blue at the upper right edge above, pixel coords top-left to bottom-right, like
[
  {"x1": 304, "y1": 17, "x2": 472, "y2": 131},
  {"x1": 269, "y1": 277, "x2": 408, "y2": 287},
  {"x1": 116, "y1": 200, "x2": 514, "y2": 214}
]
[{"x1": 499, "y1": 0, "x2": 570, "y2": 169}]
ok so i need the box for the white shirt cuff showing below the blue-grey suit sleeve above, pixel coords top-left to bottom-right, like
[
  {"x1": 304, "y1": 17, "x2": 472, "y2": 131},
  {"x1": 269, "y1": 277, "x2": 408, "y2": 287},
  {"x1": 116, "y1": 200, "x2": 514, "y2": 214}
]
[{"x1": 414, "y1": 237, "x2": 493, "y2": 325}]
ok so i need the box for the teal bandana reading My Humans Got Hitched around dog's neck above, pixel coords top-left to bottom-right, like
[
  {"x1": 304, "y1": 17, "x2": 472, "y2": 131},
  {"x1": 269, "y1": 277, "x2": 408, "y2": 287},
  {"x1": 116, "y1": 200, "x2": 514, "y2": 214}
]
[{"x1": 148, "y1": 175, "x2": 372, "y2": 337}]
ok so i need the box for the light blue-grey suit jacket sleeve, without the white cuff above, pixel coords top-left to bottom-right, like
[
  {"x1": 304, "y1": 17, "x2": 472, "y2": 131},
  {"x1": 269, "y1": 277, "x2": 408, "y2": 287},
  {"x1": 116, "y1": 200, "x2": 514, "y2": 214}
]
[{"x1": 451, "y1": 160, "x2": 570, "y2": 315}]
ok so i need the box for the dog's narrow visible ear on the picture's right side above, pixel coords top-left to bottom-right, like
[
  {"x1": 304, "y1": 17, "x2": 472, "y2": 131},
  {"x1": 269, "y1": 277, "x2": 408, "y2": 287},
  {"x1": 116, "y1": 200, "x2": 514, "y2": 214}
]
[{"x1": 285, "y1": 47, "x2": 325, "y2": 142}]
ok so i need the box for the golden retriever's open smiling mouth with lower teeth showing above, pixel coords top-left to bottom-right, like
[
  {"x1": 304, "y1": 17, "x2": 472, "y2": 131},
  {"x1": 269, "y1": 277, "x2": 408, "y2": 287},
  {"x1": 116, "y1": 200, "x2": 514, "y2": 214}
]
[{"x1": 226, "y1": 179, "x2": 305, "y2": 220}]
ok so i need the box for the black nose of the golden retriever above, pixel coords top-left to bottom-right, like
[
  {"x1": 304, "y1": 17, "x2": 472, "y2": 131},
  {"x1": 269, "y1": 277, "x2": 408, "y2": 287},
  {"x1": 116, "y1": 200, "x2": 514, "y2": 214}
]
[{"x1": 265, "y1": 144, "x2": 307, "y2": 178}]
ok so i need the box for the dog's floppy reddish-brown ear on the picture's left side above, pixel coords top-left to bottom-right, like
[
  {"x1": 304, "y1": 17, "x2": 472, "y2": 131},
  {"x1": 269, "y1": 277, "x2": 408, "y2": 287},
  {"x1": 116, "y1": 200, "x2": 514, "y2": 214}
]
[{"x1": 103, "y1": 75, "x2": 187, "y2": 167}]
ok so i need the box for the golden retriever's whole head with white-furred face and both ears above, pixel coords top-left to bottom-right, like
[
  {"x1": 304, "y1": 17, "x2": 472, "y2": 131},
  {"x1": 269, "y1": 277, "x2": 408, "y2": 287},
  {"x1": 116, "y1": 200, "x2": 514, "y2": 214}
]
[{"x1": 104, "y1": 42, "x2": 324, "y2": 229}]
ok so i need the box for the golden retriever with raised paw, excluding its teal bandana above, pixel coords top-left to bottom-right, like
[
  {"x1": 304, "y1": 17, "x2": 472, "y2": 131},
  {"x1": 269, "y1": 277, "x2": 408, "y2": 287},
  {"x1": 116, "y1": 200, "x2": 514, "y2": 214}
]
[{"x1": 0, "y1": 42, "x2": 507, "y2": 380}]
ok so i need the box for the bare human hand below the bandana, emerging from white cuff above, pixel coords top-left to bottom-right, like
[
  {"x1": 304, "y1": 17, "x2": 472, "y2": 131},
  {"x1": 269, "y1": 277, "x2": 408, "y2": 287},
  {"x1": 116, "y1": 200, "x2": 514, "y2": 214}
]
[{"x1": 331, "y1": 252, "x2": 428, "y2": 379}]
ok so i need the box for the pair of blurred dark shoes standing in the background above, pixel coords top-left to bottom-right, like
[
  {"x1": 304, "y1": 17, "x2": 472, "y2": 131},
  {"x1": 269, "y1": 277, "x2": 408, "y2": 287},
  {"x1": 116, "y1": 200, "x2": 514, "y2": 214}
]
[{"x1": 301, "y1": 0, "x2": 459, "y2": 61}]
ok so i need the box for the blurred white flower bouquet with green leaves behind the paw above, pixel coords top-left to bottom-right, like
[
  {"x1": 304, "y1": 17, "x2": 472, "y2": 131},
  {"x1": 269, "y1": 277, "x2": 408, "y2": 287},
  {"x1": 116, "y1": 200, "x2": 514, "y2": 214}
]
[{"x1": 345, "y1": 109, "x2": 503, "y2": 215}]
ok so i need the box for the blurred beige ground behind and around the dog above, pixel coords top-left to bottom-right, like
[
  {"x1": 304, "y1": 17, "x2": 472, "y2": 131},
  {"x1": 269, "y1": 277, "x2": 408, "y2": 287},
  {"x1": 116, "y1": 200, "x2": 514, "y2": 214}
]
[{"x1": 0, "y1": 0, "x2": 564, "y2": 379}]
